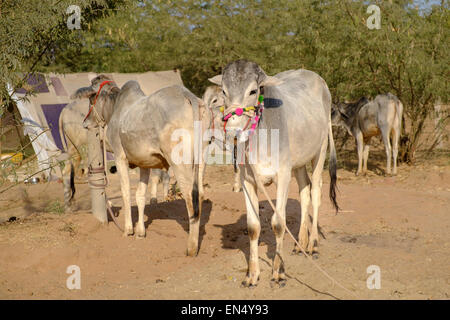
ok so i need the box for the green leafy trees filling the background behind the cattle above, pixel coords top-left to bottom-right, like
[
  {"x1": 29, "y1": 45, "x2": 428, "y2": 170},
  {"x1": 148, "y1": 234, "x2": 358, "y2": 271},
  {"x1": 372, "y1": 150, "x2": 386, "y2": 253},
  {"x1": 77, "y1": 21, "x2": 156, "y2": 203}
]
[{"x1": 0, "y1": 0, "x2": 450, "y2": 161}]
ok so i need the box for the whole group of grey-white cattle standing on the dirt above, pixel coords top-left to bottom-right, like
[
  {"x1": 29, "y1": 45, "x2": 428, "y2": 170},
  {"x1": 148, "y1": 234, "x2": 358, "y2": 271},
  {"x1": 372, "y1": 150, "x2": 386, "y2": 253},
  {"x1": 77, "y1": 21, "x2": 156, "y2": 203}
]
[{"x1": 60, "y1": 60, "x2": 403, "y2": 287}]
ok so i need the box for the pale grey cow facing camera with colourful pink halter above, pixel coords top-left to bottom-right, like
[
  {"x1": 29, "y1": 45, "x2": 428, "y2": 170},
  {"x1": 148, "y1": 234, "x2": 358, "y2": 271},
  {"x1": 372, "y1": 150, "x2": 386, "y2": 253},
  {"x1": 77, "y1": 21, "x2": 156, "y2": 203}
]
[{"x1": 210, "y1": 60, "x2": 338, "y2": 287}]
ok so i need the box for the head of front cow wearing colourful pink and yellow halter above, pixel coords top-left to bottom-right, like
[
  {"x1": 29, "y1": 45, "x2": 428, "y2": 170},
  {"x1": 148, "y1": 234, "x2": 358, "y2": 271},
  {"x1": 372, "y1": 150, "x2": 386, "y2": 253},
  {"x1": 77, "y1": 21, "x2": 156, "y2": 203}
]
[{"x1": 209, "y1": 60, "x2": 282, "y2": 136}]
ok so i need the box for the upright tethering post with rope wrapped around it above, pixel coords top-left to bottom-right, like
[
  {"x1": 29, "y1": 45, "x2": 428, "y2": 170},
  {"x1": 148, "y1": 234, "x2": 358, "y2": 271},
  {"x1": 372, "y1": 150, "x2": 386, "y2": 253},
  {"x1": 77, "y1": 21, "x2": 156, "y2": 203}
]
[{"x1": 88, "y1": 125, "x2": 108, "y2": 223}]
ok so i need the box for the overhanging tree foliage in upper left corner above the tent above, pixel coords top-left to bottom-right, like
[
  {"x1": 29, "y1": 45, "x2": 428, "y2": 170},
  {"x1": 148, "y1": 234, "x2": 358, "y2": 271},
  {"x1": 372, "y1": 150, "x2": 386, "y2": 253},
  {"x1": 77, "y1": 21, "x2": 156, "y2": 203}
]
[{"x1": 0, "y1": 0, "x2": 123, "y2": 189}]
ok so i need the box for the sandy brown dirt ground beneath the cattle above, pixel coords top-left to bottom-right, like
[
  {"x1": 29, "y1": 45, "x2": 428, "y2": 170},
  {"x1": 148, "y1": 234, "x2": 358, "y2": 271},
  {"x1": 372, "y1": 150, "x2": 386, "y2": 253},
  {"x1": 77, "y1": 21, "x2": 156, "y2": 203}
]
[{"x1": 0, "y1": 151, "x2": 450, "y2": 299}]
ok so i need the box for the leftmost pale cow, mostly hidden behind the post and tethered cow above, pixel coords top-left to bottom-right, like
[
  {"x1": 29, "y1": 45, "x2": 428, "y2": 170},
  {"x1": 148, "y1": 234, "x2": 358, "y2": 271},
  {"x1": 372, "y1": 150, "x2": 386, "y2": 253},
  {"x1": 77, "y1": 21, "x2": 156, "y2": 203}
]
[{"x1": 58, "y1": 100, "x2": 170, "y2": 212}]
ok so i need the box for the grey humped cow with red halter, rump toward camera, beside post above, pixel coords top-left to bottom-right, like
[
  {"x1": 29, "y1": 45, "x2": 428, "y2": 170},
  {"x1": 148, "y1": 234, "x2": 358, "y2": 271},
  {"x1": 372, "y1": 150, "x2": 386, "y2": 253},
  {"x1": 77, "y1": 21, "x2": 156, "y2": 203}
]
[{"x1": 72, "y1": 75, "x2": 205, "y2": 256}]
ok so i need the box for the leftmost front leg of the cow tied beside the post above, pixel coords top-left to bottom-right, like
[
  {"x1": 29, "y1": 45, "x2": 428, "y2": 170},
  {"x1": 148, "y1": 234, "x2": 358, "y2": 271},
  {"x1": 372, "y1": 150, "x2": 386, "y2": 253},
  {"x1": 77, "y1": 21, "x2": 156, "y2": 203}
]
[{"x1": 115, "y1": 153, "x2": 134, "y2": 237}]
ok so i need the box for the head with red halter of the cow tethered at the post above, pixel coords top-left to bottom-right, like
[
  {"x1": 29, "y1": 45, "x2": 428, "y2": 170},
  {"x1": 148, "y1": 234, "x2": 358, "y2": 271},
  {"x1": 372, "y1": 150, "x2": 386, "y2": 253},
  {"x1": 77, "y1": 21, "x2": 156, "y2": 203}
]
[{"x1": 70, "y1": 75, "x2": 120, "y2": 127}]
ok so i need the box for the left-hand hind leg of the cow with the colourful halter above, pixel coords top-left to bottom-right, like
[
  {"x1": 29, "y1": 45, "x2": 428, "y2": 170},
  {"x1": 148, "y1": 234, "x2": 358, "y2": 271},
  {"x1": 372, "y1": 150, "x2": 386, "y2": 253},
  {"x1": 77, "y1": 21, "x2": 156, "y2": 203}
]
[{"x1": 294, "y1": 167, "x2": 311, "y2": 253}]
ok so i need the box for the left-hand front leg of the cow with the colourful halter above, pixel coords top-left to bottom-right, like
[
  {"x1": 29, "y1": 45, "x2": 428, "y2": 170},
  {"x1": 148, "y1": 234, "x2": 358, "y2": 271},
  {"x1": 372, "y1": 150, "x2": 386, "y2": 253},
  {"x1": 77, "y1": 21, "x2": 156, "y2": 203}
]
[{"x1": 240, "y1": 168, "x2": 261, "y2": 287}]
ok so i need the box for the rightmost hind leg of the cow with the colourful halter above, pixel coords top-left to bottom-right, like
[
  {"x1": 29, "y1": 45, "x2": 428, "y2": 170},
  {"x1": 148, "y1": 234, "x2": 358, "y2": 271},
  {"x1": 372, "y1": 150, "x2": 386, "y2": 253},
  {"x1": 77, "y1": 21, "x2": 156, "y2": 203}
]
[{"x1": 308, "y1": 139, "x2": 328, "y2": 254}]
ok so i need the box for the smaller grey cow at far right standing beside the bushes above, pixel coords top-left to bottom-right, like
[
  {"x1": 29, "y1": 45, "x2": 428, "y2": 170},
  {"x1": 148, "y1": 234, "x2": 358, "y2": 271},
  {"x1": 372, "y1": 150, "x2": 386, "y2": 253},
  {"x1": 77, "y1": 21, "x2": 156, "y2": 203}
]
[{"x1": 331, "y1": 93, "x2": 403, "y2": 175}]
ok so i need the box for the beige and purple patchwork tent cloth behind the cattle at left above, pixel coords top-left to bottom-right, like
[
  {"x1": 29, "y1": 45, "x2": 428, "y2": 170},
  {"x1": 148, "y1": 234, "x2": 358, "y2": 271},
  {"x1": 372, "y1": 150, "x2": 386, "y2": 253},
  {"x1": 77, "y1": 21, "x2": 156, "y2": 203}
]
[{"x1": 8, "y1": 70, "x2": 183, "y2": 177}]
